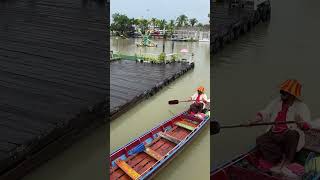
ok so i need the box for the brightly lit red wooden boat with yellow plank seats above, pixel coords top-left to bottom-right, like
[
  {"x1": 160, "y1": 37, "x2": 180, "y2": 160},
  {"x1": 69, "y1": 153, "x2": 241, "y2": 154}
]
[{"x1": 110, "y1": 112, "x2": 210, "y2": 179}]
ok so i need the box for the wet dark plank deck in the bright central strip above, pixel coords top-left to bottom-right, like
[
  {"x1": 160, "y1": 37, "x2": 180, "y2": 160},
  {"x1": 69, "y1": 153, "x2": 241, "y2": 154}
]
[{"x1": 110, "y1": 60, "x2": 194, "y2": 119}]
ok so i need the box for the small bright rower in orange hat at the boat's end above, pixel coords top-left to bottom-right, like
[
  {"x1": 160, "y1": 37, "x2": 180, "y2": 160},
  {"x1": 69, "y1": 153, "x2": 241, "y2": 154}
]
[{"x1": 188, "y1": 86, "x2": 210, "y2": 115}]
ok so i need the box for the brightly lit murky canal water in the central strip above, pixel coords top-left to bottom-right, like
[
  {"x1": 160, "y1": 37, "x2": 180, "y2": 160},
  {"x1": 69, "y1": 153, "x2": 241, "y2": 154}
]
[{"x1": 110, "y1": 39, "x2": 210, "y2": 180}]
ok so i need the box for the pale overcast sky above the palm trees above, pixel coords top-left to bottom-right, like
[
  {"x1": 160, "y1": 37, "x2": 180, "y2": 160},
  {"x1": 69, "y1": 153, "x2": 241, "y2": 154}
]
[{"x1": 110, "y1": 0, "x2": 210, "y2": 23}]
